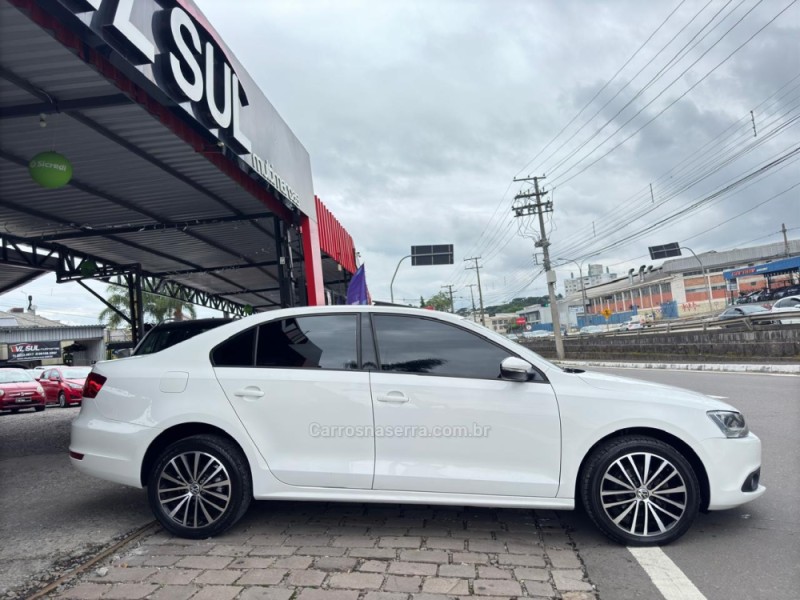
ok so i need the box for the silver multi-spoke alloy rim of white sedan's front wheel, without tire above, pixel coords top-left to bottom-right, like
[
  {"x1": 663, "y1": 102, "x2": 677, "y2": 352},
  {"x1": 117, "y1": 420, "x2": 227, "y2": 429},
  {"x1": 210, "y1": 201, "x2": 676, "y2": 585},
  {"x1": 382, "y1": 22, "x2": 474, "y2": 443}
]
[{"x1": 600, "y1": 452, "x2": 688, "y2": 538}]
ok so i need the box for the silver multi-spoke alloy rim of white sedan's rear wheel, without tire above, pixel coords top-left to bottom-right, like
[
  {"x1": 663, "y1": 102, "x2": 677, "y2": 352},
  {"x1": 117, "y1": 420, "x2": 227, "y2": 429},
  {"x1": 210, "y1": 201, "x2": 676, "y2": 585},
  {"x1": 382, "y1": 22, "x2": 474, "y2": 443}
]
[{"x1": 157, "y1": 451, "x2": 232, "y2": 529}]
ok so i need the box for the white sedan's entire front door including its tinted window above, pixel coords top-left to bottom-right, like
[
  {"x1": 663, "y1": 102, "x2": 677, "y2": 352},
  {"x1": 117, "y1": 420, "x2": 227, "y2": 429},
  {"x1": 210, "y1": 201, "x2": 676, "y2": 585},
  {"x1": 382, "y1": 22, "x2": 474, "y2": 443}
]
[{"x1": 371, "y1": 315, "x2": 561, "y2": 497}]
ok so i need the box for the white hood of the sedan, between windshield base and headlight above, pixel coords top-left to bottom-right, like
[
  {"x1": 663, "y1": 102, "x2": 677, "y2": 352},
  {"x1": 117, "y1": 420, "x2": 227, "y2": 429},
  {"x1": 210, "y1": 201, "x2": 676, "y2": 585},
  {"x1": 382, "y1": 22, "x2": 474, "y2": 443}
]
[{"x1": 576, "y1": 371, "x2": 736, "y2": 410}]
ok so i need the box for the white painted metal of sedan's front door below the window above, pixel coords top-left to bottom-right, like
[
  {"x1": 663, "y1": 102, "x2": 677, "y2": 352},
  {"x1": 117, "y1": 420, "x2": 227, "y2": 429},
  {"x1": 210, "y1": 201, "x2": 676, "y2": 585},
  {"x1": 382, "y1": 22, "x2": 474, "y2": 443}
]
[{"x1": 372, "y1": 373, "x2": 561, "y2": 498}]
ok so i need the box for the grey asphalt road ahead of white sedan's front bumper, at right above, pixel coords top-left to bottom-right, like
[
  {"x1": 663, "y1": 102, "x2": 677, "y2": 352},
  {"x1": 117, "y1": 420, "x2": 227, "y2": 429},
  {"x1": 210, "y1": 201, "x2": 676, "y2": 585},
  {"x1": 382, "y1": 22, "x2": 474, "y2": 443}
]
[{"x1": 562, "y1": 367, "x2": 800, "y2": 600}]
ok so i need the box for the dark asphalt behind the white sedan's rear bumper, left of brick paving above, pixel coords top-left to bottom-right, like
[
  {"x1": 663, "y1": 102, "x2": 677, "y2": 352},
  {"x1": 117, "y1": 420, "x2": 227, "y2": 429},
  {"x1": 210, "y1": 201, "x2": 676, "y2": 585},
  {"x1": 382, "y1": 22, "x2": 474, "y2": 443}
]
[{"x1": 0, "y1": 407, "x2": 153, "y2": 597}]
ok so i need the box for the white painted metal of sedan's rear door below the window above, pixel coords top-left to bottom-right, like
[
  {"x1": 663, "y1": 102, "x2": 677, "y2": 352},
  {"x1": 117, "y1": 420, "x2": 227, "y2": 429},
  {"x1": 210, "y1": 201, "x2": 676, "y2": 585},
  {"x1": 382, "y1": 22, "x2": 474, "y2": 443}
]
[{"x1": 215, "y1": 367, "x2": 375, "y2": 489}]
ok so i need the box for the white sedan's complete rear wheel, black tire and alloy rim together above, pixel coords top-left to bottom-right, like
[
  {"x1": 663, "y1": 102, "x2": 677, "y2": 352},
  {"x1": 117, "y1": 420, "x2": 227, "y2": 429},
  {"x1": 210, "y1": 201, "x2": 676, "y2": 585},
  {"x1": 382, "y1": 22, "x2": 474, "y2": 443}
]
[{"x1": 147, "y1": 435, "x2": 253, "y2": 539}]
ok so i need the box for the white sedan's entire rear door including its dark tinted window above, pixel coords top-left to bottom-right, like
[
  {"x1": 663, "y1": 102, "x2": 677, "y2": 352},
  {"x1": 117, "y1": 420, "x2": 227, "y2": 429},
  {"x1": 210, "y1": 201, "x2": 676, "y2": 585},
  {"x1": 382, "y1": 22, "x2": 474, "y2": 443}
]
[{"x1": 212, "y1": 314, "x2": 375, "y2": 489}]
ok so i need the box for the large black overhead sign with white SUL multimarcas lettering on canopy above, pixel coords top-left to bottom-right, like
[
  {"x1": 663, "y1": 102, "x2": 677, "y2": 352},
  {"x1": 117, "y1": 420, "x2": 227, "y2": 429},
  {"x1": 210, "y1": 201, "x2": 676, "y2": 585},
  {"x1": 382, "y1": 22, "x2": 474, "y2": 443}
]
[{"x1": 64, "y1": 0, "x2": 300, "y2": 206}]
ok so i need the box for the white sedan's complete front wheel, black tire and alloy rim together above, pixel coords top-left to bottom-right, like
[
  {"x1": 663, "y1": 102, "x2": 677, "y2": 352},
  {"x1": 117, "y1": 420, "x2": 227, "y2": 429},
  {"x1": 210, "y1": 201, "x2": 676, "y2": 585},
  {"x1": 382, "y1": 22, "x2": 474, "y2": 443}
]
[{"x1": 580, "y1": 436, "x2": 700, "y2": 546}]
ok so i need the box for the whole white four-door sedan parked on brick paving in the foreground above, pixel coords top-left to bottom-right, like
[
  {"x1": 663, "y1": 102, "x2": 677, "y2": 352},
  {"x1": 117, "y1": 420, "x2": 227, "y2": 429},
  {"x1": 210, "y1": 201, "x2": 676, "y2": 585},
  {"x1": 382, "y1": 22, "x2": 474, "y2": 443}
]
[{"x1": 70, "y1": 306, "x2": 764, "y2": 544}]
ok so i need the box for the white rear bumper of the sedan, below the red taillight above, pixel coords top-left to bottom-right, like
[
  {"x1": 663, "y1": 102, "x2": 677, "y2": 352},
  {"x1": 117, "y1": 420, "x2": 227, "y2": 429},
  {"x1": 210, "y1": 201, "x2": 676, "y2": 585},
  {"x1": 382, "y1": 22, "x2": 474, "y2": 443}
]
[{"x1": 69, "y1": 398, "x2": 159, "y2": 488}]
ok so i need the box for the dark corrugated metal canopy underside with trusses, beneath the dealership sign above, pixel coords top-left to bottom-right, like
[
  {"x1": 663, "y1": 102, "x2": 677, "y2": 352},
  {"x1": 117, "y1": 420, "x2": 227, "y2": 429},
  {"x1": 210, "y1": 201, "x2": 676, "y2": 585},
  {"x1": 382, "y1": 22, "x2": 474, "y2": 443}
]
[{"x1": 0, "y1": 0, "x2": 310, "y2": 310}]
